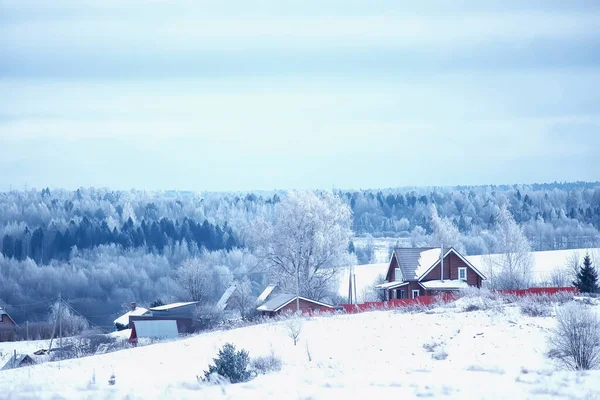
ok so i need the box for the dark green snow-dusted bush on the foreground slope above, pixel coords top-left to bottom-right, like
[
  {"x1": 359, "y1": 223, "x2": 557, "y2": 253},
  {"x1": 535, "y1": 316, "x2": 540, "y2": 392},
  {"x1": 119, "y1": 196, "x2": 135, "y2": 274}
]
[{"x1": 204, "y1": 343, "x2": 251, "y2": 383}]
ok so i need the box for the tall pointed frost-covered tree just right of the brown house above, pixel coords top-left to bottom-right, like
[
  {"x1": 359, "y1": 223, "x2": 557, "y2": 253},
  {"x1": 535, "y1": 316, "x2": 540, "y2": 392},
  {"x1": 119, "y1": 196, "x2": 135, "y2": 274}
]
[{"x1": 484, "y1": 205, "x2": 533, "y2": 289}]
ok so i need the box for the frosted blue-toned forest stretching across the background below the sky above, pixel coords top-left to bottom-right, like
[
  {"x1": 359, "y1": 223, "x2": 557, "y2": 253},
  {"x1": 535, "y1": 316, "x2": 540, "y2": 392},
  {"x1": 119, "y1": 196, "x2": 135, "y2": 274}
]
[{"x1": 0, "y1": 182, "x2": 600, "y2": 326}]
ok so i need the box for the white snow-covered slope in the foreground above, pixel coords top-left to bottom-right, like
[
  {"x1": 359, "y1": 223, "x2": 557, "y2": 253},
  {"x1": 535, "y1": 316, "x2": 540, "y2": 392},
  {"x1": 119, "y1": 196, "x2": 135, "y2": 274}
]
[{"x1": 0, "y1": 299, "x2": 600, "y2": 400}]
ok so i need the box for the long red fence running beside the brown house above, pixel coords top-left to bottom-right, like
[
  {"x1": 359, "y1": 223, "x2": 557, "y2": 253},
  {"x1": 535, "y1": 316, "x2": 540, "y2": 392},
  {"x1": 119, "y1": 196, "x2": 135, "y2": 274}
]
[{"x1": 340, "y1": 287, "x2": 579, "y2": 313}]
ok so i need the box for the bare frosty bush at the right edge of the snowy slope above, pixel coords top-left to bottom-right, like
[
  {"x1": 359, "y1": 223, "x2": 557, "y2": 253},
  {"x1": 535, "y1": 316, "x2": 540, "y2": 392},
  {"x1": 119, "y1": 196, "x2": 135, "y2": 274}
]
[{"x1": 548, "y1": 303, "x2": 600, "y2": 370}]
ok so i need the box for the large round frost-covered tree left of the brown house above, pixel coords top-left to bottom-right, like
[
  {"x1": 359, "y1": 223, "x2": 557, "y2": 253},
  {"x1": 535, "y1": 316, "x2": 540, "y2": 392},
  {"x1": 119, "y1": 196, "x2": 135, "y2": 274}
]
[{"x1": 254, "y1": 192, "x2": 355, "y2": 299}]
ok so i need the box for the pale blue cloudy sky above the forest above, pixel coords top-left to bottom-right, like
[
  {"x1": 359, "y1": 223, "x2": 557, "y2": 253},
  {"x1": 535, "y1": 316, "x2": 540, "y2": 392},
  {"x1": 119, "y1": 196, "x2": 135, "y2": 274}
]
[{"x1": 0, "y1": 0, "x2": 600, "y2": 191}]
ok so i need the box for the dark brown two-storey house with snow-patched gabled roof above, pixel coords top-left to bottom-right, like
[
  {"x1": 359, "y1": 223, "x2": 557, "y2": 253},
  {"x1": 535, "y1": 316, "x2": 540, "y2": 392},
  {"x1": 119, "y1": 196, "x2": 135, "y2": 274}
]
[{"x1": 376, "y1": 247, "x2": 486, "y2": 299}]
